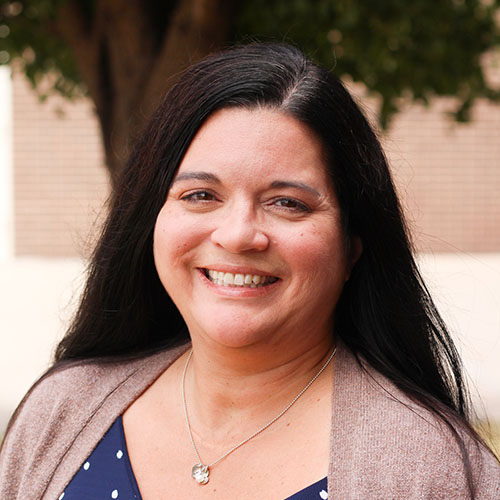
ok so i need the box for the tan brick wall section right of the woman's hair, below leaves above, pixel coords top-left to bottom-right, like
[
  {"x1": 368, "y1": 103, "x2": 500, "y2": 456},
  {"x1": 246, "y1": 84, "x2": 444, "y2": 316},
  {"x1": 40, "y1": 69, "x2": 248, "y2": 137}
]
[{"x1": 384, "y1": 99, "x2": 500, "y2": 252}]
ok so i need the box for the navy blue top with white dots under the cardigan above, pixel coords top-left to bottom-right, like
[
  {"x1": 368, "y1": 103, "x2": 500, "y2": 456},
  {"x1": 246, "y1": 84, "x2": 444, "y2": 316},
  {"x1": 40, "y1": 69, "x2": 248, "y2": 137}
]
[{"x1": 59, "y1": 416, "x2": 328, "y2": 500}]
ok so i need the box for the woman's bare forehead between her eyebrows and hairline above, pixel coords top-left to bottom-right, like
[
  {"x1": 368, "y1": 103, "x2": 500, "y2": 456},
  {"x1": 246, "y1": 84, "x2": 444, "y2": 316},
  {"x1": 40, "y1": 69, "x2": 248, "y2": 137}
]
[{"x1": 177, "y1": 108, "x2": 331, "y2": 188}]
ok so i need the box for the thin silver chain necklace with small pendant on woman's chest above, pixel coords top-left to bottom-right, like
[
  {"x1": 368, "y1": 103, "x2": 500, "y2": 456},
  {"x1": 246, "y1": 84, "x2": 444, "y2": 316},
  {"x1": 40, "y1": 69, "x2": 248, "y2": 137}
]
[{"x1": 182, "y1": 348, "x2": 337, "y2": 484}]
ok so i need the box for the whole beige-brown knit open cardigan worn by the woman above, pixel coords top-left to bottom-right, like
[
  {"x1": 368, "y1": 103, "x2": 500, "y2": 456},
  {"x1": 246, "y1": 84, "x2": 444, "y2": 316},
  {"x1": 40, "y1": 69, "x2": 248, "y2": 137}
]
[{"x1": 0, "y1": 347, "x2": 500, "y2": 500}]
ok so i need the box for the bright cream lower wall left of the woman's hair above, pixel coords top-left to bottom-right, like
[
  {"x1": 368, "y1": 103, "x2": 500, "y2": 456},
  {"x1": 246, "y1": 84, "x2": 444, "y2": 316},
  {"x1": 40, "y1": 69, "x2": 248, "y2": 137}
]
[{"x1": 0, "y1": 257, "x2": 84, "y2": 437}]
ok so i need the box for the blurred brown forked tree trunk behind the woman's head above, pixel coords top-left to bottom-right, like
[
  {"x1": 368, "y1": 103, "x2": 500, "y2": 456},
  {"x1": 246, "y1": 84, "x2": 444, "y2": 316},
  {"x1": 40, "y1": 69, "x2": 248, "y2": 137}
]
[{"x1": 57, "y1": 0, "x2": 234, "y2": 190}]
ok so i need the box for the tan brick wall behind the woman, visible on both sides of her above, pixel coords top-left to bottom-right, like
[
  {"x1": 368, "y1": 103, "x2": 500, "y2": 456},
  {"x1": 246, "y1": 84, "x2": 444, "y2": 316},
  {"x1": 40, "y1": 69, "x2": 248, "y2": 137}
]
[{"x1": 13, "y1": 68, "x2": 500, "y2": 256}]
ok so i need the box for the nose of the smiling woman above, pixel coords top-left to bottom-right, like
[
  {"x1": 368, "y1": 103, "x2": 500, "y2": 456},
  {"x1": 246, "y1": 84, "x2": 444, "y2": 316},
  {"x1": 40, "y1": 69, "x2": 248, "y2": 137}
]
[{"x1": 211, "y1": 205, "x2": 269, "y2": 253}]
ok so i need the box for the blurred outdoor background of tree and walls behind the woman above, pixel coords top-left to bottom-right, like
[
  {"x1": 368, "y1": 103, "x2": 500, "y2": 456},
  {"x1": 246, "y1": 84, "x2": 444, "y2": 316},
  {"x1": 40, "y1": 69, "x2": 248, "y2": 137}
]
[{"x1": 0, "y1": 0, "x2": 500, "y2": 446}]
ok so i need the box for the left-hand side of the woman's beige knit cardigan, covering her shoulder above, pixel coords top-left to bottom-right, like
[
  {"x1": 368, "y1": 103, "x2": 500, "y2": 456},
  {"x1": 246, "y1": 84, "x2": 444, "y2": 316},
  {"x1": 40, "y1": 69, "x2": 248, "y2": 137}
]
[{"x1": 0, "y1": 347, "x2": 185, "y2": 498}]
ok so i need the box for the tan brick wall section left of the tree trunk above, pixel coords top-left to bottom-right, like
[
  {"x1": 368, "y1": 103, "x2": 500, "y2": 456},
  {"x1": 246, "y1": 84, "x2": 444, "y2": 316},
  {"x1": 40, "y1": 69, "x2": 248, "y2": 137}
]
[{"x1": 12, "y1": 74, "x2": 108, "y2": 256}]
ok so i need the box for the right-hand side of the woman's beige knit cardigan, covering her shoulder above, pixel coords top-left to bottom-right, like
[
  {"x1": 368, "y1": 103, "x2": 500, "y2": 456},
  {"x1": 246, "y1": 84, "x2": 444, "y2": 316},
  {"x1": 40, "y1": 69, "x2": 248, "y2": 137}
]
[{"x1": 332, "y1": 346, "x2": 500, "y2": 499}]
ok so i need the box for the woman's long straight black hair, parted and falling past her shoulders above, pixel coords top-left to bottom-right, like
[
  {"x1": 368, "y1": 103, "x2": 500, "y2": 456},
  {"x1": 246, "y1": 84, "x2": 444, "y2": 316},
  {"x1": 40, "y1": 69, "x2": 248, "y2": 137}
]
[{"x1": 51, "y1": 44, "x2": 492, "y2": 490}]
